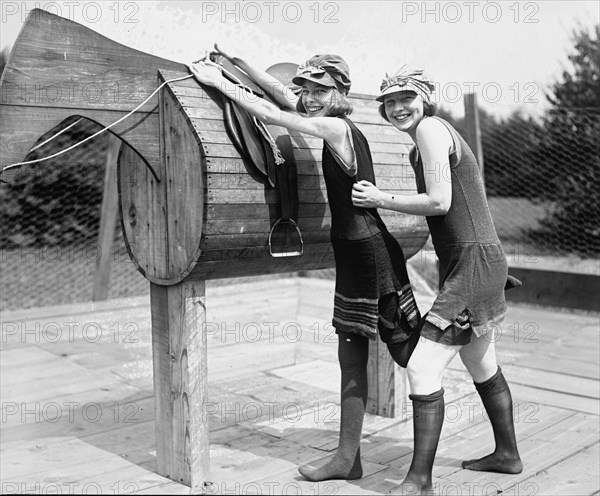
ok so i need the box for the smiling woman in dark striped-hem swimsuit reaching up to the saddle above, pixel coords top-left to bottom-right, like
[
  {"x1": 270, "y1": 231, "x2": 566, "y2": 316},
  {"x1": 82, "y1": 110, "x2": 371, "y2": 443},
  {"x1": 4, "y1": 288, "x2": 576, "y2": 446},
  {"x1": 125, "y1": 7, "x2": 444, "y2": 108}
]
[{"x1": 191, "y1": 50, "x2": 420, "y2": 481}]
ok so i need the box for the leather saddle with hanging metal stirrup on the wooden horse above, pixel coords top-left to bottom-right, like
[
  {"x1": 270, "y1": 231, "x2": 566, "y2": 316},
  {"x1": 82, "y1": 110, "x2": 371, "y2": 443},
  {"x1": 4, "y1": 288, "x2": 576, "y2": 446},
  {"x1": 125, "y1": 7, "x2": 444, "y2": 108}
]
[{"x1": 211, "y1": 56, "x2": 304, "y2": 257}]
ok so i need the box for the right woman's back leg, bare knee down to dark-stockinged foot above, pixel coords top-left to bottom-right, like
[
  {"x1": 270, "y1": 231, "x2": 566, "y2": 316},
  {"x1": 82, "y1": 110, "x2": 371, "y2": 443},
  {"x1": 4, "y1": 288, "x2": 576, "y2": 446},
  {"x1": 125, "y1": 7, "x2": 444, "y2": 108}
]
[{"x1": 460, "y1": 334, "x2": 523, "y2": 474}]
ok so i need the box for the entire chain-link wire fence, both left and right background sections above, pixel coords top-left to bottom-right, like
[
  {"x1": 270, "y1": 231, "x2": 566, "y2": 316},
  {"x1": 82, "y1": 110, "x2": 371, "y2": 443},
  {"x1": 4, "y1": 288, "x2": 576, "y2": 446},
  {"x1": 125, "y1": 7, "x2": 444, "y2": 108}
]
[{"x1": 0, "y1": 101, "x2": 600, "y2": 309}]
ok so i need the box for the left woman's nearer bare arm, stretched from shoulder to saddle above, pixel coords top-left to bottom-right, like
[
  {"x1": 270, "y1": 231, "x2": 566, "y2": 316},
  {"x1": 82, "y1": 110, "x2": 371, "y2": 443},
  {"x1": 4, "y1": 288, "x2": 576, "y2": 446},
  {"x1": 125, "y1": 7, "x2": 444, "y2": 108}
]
[{"x1": 190, "y1": 61, "x2": 346, "y2": 146}]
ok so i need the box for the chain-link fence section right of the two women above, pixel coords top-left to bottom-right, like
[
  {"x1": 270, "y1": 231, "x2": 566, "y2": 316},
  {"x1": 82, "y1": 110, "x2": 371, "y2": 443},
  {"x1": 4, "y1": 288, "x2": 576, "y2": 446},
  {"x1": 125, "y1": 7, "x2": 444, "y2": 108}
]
[{"x1": 481, "y1": 109, "x2": 600, "y2": 272}]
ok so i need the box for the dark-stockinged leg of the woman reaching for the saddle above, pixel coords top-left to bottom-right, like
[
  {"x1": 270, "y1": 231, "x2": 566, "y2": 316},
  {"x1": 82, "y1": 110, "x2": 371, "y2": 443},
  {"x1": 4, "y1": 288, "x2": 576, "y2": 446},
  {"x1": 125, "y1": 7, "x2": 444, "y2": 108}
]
[{"x1": 298, "y1": 332, "x2": 369, "y2": 482}]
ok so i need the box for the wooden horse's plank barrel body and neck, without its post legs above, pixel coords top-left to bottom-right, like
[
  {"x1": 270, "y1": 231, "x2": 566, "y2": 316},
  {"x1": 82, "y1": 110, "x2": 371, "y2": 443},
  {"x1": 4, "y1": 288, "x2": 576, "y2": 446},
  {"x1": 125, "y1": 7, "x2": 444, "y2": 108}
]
[{"x1": 0, "y1": 9, "x2": 428, "y2": 285}]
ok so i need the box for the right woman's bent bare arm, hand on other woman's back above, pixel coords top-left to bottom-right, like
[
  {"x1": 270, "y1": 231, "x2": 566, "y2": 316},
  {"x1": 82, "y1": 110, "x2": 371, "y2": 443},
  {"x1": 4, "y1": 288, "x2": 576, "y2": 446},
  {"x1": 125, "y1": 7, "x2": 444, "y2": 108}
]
[{"x1": 352, "y1": 119, "x2": 452, "y2": 216}]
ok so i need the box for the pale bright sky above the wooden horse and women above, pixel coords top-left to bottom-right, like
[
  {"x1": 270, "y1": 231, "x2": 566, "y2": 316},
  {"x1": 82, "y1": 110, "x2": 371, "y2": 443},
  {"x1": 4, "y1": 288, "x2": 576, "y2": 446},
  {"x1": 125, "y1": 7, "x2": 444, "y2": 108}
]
[{"x1": 0, "y1": 0, "x2": 600, "y2": 117}]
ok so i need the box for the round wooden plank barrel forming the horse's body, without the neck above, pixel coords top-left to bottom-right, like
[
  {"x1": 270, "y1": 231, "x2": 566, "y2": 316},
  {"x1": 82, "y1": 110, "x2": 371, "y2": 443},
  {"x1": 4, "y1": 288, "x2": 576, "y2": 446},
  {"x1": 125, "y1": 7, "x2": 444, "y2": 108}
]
[{"x1": 119, "y1": 71, "x2": 428, "y2": 285}]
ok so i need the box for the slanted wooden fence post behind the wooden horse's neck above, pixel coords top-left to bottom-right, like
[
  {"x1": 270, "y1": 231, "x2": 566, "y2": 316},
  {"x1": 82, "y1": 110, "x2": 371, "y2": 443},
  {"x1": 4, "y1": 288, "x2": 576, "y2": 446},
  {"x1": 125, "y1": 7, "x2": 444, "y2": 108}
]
[{"x1": 92, "y1": 133, "x2": 121, "y2": 301}]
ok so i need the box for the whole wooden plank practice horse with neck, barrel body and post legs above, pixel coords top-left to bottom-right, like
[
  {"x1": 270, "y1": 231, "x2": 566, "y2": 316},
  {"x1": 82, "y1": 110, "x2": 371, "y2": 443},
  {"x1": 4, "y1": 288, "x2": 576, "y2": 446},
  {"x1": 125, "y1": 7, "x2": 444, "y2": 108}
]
[{"x1": 0, "y1": 9, "x2": 428, "y2": 490}]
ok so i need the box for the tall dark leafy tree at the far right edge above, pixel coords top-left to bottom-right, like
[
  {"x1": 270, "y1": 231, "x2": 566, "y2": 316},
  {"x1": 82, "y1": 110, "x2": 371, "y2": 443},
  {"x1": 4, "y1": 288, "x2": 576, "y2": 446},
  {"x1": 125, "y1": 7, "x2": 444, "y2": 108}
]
[{"x1": 536, "y1": 25, "x2": 600, "y2": 256}]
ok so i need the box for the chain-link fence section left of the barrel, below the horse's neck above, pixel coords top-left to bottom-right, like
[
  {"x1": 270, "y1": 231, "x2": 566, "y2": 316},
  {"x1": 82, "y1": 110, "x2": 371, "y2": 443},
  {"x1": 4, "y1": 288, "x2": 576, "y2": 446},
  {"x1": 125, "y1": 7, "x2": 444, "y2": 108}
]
[{"x1": 0, "y1": 119, "x2": 149, "y2": 310}]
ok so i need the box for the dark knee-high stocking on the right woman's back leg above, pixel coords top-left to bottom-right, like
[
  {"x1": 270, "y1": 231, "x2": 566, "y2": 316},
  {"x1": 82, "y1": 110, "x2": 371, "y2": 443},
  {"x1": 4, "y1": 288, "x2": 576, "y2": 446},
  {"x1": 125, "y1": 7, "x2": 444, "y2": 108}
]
[{"x1": 462, "y1": 367, "x2": 523, "y2": 474}]
